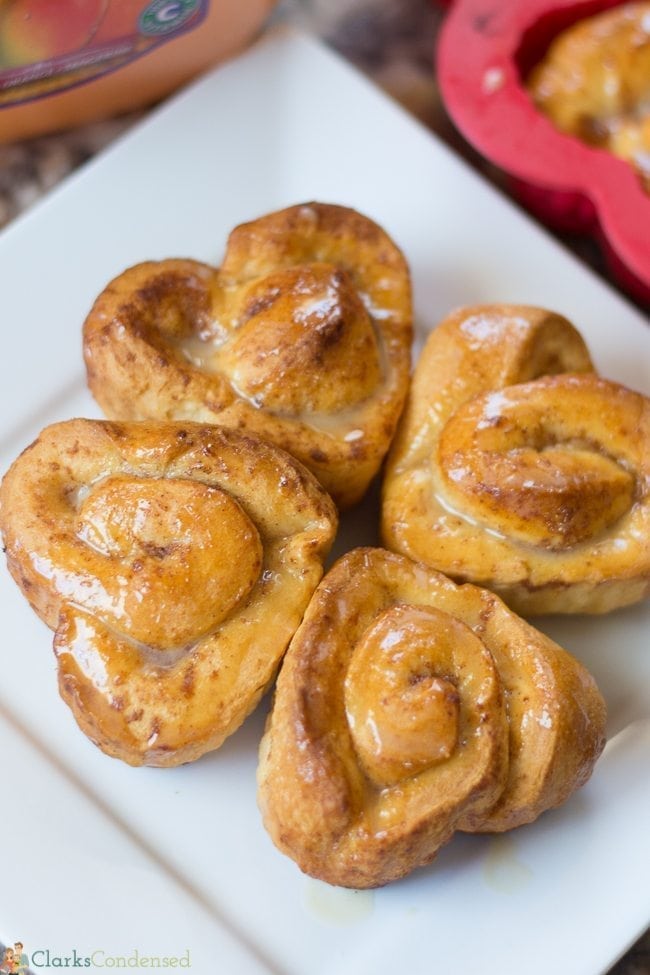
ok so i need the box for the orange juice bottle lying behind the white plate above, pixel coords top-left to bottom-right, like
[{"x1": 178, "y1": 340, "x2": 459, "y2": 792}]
[{"x1": 0, "y1": 0, "x2": 274, "y2": 142}]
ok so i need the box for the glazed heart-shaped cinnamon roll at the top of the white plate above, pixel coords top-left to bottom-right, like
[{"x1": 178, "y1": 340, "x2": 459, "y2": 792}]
[{"x1": 84, "y1": 203, "x2": 411, "y2": 507}]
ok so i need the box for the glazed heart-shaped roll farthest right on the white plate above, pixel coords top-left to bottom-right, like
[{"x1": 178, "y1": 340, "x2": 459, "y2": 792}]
[{"x1": 382, "y1": 305, "x2": 650, "y2": 614}]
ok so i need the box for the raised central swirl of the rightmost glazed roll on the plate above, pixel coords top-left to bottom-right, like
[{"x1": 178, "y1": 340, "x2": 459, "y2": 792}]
[{"x1": 438, "y1": 374, "x2": 639, "y2": 549}]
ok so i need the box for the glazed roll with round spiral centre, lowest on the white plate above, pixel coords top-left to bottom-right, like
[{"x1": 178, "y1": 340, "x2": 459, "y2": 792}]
[{"x1": 258, "y1": 549, "x2": 605, "y2": 888}]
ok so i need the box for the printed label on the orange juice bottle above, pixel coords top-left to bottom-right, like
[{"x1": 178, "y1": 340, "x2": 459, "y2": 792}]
[{"x1": 0, "y1": 0, "x2": 209, "y2": 108}]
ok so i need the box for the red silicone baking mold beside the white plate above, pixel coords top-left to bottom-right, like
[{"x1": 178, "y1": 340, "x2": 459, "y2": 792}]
[{"x1": 437, "y1": 0, "x2": 650, "y2": 302}]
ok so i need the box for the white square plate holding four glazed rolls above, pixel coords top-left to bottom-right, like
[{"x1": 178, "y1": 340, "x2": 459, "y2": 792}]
[{"x1": 0, "y1": 22, "x2": 650, "y2": 975}]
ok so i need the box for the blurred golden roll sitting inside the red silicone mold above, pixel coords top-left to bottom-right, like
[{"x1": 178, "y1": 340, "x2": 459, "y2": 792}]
[{"x1": 528, "y1": 2, "x2": 650, "y2": 192}]
